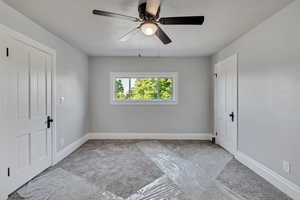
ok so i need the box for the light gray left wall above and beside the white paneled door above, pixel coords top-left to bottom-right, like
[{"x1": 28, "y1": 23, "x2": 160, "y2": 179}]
[{"x1": 0, "y1": 1, "x2": 88, "y2": 150}]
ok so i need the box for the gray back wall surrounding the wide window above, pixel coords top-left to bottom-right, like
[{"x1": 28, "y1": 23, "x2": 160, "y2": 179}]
[{"x1": 89, "y1": 57, "x2": 212, "y2": 133}]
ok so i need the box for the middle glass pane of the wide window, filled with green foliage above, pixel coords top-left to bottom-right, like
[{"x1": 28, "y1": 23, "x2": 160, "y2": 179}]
[{"x1": 131, "y1": 78, "x2": 159, "y2": 100}]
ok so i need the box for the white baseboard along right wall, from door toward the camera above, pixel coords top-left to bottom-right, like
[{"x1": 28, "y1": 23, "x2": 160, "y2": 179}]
[{"x1": 236, "y1": 152, "x2": 300, "y2": 200}]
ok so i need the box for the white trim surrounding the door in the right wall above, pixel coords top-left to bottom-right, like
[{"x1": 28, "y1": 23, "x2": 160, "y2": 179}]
[{"x1": 214, "y1": 53, "x2": 239, "y2": 156}]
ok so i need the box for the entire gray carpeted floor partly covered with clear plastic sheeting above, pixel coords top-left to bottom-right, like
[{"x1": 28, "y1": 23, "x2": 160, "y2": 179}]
[{"x1": 9, "y1": 140, "x2": 290, "y2": 200}]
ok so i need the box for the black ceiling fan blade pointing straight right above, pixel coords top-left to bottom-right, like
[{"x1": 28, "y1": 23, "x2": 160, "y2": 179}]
[{"x1": 159, "y1": 16, "x2": 204, "y2": 25}]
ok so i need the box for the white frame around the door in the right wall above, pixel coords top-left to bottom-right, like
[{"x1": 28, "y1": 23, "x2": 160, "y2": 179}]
[{"x1": 213, "y1": 53, "x2": 239, "y2": 156}]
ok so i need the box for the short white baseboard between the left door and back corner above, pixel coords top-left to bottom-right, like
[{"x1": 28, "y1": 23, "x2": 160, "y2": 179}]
[{"x1": 54, "y1": 134, "x2": 89, "y2": 164}]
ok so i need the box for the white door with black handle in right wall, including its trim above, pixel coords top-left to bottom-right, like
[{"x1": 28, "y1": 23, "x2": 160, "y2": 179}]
[{"x1": 215, "y1": 55, "x2": 237, "y2": 154}]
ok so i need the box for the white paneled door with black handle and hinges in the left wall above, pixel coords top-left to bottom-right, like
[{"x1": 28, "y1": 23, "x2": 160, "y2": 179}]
[{"x1": 0, "y1": 32, "x2": 52, "y2": 195}]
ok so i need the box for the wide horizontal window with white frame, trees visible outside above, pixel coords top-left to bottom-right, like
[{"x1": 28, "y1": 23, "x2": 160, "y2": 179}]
[{"x1": 111, "y1": 72, "x2": 177, "y2": 104}]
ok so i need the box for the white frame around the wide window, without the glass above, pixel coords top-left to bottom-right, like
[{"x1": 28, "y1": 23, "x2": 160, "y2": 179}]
[{"x1": 110, "y1": 72, "x2": 178, "y2": 105}]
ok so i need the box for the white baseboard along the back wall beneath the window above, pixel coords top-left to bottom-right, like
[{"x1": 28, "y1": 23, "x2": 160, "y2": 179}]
[{"x1": 88, "y1": 133, "x2": 212, "y2": 140}]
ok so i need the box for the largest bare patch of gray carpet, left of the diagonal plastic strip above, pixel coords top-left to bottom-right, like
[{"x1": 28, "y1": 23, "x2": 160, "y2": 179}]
[{"x1": 58, "y1": 141, "x2": 163, "y2": 198}]
